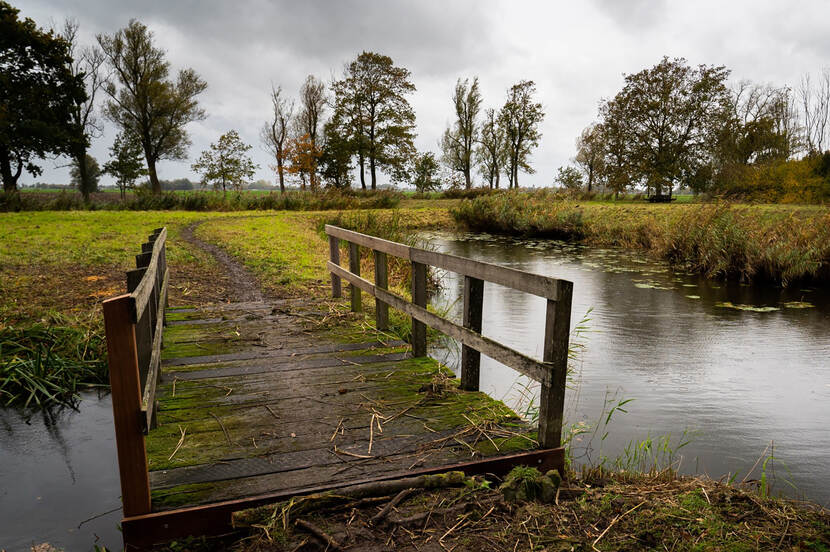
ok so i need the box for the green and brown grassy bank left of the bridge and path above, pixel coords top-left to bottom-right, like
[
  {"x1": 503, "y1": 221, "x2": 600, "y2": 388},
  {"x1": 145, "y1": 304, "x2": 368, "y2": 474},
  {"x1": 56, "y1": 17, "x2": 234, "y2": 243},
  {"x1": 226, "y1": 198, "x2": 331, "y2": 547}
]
[{"x1": 0, "y1": 212, "x2": 234, "y2": 407}]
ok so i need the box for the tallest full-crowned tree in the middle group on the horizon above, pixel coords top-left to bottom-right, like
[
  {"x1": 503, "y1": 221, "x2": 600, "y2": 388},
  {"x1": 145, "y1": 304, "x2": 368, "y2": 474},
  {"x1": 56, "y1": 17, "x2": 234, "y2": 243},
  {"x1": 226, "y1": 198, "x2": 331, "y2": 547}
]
[{"x1": 332, "y1": 52, "x2": 415, "y2": 190}]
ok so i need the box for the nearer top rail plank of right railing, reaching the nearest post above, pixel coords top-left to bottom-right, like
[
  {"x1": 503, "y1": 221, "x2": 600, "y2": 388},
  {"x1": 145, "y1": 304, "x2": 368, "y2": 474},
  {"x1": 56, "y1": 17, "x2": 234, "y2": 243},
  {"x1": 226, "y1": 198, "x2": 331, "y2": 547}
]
[{"x1": 410, "y1": 248, "x2": 559, "y2": 300}]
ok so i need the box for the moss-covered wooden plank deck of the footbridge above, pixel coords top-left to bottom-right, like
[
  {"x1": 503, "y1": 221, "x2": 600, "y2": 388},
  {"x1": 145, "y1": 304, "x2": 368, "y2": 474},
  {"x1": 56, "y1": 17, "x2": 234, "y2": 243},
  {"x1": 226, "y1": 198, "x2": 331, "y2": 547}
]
[{"x1": 147, "y1": 226, "x2": 536, "y2": 510}]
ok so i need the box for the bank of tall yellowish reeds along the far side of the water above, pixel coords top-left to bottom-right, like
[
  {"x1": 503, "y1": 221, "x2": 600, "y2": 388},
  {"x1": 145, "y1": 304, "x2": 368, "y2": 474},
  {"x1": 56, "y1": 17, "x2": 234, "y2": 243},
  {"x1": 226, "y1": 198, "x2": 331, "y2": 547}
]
[{"x1": 451, "y1": 191, "x2": 830, "y2": 285}]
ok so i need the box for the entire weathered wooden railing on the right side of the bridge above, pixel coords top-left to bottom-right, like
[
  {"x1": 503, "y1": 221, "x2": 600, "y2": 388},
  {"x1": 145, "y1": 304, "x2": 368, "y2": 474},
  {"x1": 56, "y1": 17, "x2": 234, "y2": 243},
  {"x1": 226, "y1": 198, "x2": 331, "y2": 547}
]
[{"x1": 326, "y1": 225, "x2": 573, "y2": 448}]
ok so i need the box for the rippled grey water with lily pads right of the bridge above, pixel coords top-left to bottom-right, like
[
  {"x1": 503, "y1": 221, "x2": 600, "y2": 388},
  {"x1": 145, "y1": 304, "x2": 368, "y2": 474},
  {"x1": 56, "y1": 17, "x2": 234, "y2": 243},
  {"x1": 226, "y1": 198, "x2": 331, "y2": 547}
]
[{"x1": 423, "y1": 233, "x2": 830, "y2": 505}]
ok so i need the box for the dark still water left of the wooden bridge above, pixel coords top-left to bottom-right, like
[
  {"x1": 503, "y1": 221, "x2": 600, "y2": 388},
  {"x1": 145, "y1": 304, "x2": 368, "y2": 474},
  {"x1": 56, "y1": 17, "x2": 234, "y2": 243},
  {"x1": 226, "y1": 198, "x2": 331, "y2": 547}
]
[{"x1": 0, "y1": 393, "x2": 121, "y2": 552}]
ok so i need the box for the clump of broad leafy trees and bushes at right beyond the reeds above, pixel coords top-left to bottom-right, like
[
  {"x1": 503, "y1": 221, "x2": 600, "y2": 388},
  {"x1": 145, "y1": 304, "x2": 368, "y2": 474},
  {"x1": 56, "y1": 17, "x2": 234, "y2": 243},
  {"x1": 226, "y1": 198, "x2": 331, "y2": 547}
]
[{"x1": 556, "y1": 57, "x2": 830, "y2": 200}]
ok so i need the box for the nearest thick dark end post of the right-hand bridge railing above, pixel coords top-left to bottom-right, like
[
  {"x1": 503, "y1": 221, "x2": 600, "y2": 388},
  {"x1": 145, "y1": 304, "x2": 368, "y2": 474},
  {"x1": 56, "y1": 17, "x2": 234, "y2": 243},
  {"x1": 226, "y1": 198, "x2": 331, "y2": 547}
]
[{"x1": 539, "y1": 280, "x2": 573, "y2": 448}]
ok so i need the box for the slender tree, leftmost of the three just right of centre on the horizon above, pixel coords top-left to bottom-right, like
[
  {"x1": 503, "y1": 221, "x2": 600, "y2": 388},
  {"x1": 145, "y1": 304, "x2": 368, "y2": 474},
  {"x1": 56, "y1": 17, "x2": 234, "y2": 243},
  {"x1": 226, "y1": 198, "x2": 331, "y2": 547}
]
[{"x1": 441, "y1": 77, "x2": 481, "y2": 190}]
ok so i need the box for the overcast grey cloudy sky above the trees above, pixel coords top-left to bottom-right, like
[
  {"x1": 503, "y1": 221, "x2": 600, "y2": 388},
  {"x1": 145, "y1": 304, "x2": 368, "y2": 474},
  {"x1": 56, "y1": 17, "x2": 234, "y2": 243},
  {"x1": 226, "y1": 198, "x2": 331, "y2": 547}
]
[{"x1": 16, "y1": 0, "x2": 830, "y2": 186}]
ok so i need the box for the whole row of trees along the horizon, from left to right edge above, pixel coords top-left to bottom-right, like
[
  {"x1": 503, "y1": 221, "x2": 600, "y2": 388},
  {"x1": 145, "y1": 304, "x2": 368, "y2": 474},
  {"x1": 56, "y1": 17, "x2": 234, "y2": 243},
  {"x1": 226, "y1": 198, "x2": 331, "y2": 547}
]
[{"x1": 0, "y1": 1, "x2": 830, "y2": 200}]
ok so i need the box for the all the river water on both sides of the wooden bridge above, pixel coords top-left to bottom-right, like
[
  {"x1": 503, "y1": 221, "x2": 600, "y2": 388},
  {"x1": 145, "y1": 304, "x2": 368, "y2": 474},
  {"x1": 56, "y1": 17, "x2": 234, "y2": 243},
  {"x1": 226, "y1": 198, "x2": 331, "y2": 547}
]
[{"x1": 0, "y1": 233, "x2": 830, "y2": 552}]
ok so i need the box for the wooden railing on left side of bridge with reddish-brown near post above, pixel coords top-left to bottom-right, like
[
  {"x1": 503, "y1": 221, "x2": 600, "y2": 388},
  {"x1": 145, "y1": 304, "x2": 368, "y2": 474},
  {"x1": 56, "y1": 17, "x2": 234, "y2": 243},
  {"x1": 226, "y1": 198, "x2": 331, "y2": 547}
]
[{"x1": 104, "y1": 228, "x2": 169, "y2": 516}]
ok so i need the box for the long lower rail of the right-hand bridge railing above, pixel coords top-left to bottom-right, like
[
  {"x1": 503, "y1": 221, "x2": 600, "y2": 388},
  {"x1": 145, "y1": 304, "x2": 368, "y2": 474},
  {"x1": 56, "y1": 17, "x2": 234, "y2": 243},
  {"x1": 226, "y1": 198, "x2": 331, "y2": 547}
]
[{"x1": 328, "y1": 264, "x2": 552, "y2": 382}]
